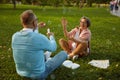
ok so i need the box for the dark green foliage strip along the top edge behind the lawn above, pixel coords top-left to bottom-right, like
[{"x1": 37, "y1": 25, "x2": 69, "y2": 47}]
[{"x1": 0, "y1": 0, "x2": 110, "y2": 7}]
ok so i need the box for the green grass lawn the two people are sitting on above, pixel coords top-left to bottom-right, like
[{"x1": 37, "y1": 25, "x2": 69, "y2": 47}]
[{"x1": 0, "y1": 4, "x2": 120, "y2": 80}]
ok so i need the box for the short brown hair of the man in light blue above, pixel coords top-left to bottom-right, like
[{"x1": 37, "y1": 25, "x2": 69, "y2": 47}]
[{"x1": 20, "y1": 10, "x2": 35, "y2": 25}]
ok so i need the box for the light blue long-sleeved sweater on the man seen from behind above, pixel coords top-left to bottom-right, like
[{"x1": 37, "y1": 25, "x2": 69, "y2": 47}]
[{"x1": 12, "y1": 29, "x2": 57, "y2": 77}]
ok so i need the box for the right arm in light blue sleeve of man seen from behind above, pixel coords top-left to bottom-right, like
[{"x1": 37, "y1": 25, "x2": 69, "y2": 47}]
[{"x1": 34, "y1": 34, "x2": 57, "y2": 52}]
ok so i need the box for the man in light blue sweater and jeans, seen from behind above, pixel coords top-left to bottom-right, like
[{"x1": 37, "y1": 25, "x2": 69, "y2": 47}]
[{"x1": 12, "y1": 10, "x2": 67, "y2": 80}]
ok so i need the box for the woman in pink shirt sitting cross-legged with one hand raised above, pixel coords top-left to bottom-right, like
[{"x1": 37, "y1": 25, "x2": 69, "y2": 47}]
[{"x1": 59, "y1": 17, "x2": 91, "y2": 58}]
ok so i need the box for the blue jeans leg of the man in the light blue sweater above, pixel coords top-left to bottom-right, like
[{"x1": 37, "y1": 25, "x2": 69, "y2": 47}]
[{"x1": 37, "y1": 51, "x2": 67, "y2": 80}]
